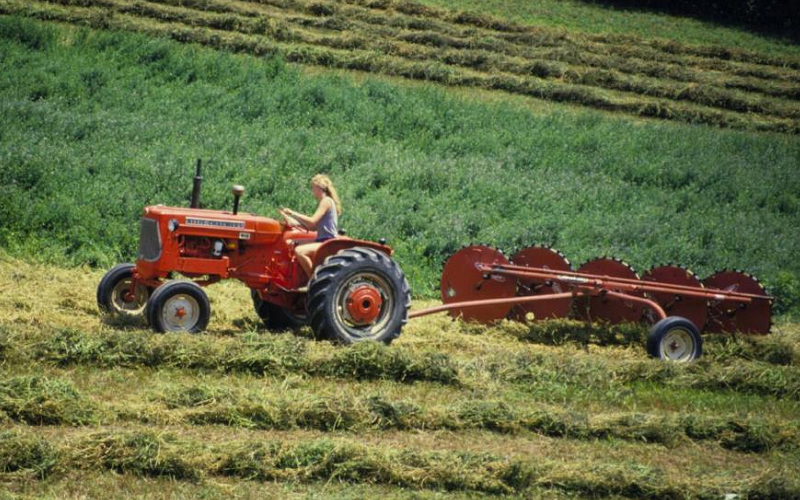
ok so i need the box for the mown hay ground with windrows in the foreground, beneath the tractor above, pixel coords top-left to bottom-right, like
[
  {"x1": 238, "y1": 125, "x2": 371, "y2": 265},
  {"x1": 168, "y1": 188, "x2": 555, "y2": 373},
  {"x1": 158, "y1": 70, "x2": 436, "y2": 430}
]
[{"x1": 0, "y1": 257, "x2": 800, "y2": 499}]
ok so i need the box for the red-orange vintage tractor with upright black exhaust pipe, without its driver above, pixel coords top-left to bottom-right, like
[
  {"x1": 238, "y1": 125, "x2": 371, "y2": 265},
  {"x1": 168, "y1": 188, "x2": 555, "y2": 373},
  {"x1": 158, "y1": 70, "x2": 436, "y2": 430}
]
[{"x1": 97, "y1": 161, "x2": 411, "y2": 343}]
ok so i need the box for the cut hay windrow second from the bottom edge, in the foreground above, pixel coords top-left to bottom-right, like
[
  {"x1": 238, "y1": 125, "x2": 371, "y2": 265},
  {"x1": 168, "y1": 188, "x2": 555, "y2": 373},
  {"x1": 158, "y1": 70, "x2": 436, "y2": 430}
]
[{"x1": 0, "y1": 356, "x2": 800, "y2": 453}]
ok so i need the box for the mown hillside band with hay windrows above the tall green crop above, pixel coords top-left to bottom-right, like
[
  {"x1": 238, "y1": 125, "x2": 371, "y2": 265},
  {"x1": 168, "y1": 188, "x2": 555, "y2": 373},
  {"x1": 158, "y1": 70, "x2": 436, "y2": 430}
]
[{"x1": 0, "y1": 0, "x2": 800, "y2": 134}]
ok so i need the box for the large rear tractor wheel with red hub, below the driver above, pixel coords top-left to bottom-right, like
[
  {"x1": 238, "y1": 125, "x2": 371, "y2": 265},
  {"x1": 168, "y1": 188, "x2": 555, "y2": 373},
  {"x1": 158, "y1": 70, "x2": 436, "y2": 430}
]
[{"x1": 306, "y1": 247, "x2": 411, "y2": 344}]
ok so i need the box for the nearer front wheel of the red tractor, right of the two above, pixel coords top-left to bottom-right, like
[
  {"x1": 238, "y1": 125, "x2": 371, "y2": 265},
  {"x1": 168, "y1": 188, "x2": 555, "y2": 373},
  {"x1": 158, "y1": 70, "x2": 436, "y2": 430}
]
[{"x1": 145, "y1": 280, "x2": 211, "y2": 333}]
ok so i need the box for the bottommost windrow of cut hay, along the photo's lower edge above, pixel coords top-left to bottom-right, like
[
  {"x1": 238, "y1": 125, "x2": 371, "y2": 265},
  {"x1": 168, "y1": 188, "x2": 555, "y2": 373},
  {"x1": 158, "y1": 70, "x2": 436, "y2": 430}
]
[{"x1": 0, "y1": 428, "x2": 800, "y2": 499}]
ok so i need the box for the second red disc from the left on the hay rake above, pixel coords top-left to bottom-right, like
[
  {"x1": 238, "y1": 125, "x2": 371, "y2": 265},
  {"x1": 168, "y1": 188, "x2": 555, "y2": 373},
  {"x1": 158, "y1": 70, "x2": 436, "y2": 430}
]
[{"x1": 511, "y1": 246, "x2": 572, "y2": 321}]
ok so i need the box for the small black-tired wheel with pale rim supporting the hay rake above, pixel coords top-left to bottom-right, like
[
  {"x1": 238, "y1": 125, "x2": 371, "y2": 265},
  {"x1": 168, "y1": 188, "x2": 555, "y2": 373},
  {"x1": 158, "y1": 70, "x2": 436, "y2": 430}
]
[{"x1": 647, "y1": 316, "x2": 703, "y2": 363}]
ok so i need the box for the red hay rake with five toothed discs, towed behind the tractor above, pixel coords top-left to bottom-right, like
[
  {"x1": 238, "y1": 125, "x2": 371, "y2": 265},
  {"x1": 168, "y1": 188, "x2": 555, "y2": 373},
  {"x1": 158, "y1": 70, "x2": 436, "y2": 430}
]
[{"x1": 409, "y1": 245, "x2": 773, "y2": 361}]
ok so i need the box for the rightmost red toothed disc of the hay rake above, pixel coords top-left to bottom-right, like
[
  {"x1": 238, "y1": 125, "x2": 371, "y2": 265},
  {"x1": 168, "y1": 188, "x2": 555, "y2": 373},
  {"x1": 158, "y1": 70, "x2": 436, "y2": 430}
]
[{"x1": 703, "y1": 271, "x2": 772, "y2": 335}]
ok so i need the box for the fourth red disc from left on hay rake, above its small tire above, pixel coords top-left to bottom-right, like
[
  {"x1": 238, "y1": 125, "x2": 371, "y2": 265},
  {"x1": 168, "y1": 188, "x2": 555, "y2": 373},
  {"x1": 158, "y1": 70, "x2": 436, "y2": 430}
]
[{"x1": 642, "y1": 265, "x2": 708, "y2": 330}]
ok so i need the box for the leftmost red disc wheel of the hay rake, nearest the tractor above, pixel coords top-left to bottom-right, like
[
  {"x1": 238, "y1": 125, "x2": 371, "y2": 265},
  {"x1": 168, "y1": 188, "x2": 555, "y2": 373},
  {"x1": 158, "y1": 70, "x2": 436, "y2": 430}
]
[{"x1": 440, "y1": 245, "x2": 516, "y2": 323}]
